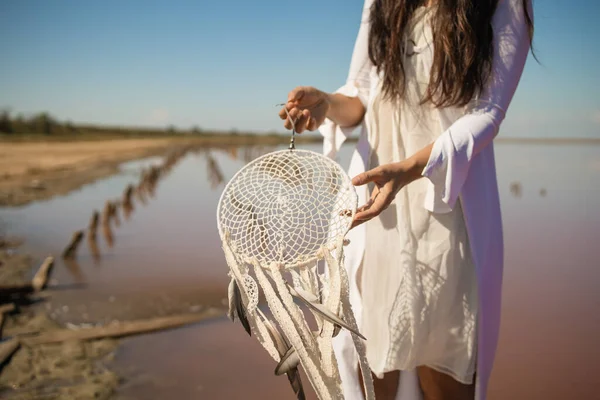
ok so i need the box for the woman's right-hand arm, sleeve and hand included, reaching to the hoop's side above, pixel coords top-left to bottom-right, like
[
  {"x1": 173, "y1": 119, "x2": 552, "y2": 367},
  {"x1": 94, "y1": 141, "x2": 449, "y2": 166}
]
[{"x1": 353, "y1": 0, "x2": 530, "y2": 225}]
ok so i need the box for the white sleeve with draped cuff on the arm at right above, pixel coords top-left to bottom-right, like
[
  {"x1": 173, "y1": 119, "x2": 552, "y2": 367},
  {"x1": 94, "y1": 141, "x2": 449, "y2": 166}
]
[{"x1": 422, "y1": 0, "x2": 531, "y2": 212}]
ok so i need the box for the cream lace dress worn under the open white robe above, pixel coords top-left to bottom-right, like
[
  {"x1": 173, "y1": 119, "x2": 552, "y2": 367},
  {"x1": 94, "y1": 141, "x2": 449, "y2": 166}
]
[{"x1": 359, "y1": 8, "x2": 478, "y2": 384}]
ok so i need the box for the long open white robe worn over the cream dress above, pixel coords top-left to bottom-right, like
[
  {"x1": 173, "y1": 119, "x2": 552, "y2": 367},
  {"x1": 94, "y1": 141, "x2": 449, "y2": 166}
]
[{"x1": 319, "y1": 0, "x2": 531, "y2": 400}]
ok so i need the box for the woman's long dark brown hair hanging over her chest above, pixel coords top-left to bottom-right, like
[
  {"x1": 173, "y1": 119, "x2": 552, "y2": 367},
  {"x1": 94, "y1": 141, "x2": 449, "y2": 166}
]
[{"x1": 369, "y1": 0, "x2": 533, "y2": 107}]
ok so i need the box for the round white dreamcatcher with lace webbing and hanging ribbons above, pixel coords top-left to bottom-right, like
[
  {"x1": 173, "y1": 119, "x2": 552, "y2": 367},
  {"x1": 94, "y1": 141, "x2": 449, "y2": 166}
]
[{"x1": 217, "y1": 150, "x2": 375, "y2": 400}]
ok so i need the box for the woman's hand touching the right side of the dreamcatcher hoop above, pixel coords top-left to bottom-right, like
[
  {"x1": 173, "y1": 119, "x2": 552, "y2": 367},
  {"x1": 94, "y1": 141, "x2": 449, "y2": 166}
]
[{"x1": 351, "y1": 159, "x2": 423, "y2": 228}]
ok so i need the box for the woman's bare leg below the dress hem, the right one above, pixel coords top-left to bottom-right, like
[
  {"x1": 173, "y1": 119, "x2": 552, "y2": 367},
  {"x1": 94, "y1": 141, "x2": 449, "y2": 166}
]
[{"x1": 417, "y1": 367, "x2": 475, "y2": 400}]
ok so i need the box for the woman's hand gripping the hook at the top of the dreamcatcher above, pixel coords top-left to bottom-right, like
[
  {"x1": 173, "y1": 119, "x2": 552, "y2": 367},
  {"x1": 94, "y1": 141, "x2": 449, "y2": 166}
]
[{"x1": 279, "y1": 86, "x2": 330, "y2": 133}]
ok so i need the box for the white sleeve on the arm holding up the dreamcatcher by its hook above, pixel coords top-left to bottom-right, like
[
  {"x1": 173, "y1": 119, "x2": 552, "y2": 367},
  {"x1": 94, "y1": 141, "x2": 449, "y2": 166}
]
[{"x1": 319, "y1": 0, "x2": 373, "y2": 158}]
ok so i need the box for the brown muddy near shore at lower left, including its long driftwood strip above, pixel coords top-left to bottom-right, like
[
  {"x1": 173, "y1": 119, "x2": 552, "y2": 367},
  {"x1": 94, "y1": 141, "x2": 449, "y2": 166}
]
[{"x1": 0, "y1": 237, "x2": 224, "y2": 400}]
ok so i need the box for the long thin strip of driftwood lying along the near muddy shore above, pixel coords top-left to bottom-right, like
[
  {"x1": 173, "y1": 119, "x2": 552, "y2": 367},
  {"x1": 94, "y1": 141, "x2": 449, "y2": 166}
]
[{"x1": 21, "y1": 309, "x2": 223, "y2": 346}]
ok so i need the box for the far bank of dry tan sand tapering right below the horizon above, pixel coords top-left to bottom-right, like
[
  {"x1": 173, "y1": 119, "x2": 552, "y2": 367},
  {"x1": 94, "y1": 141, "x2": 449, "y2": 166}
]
[{"x1": 0, "y1": 135, "x2": 320, "y2": 207}]
